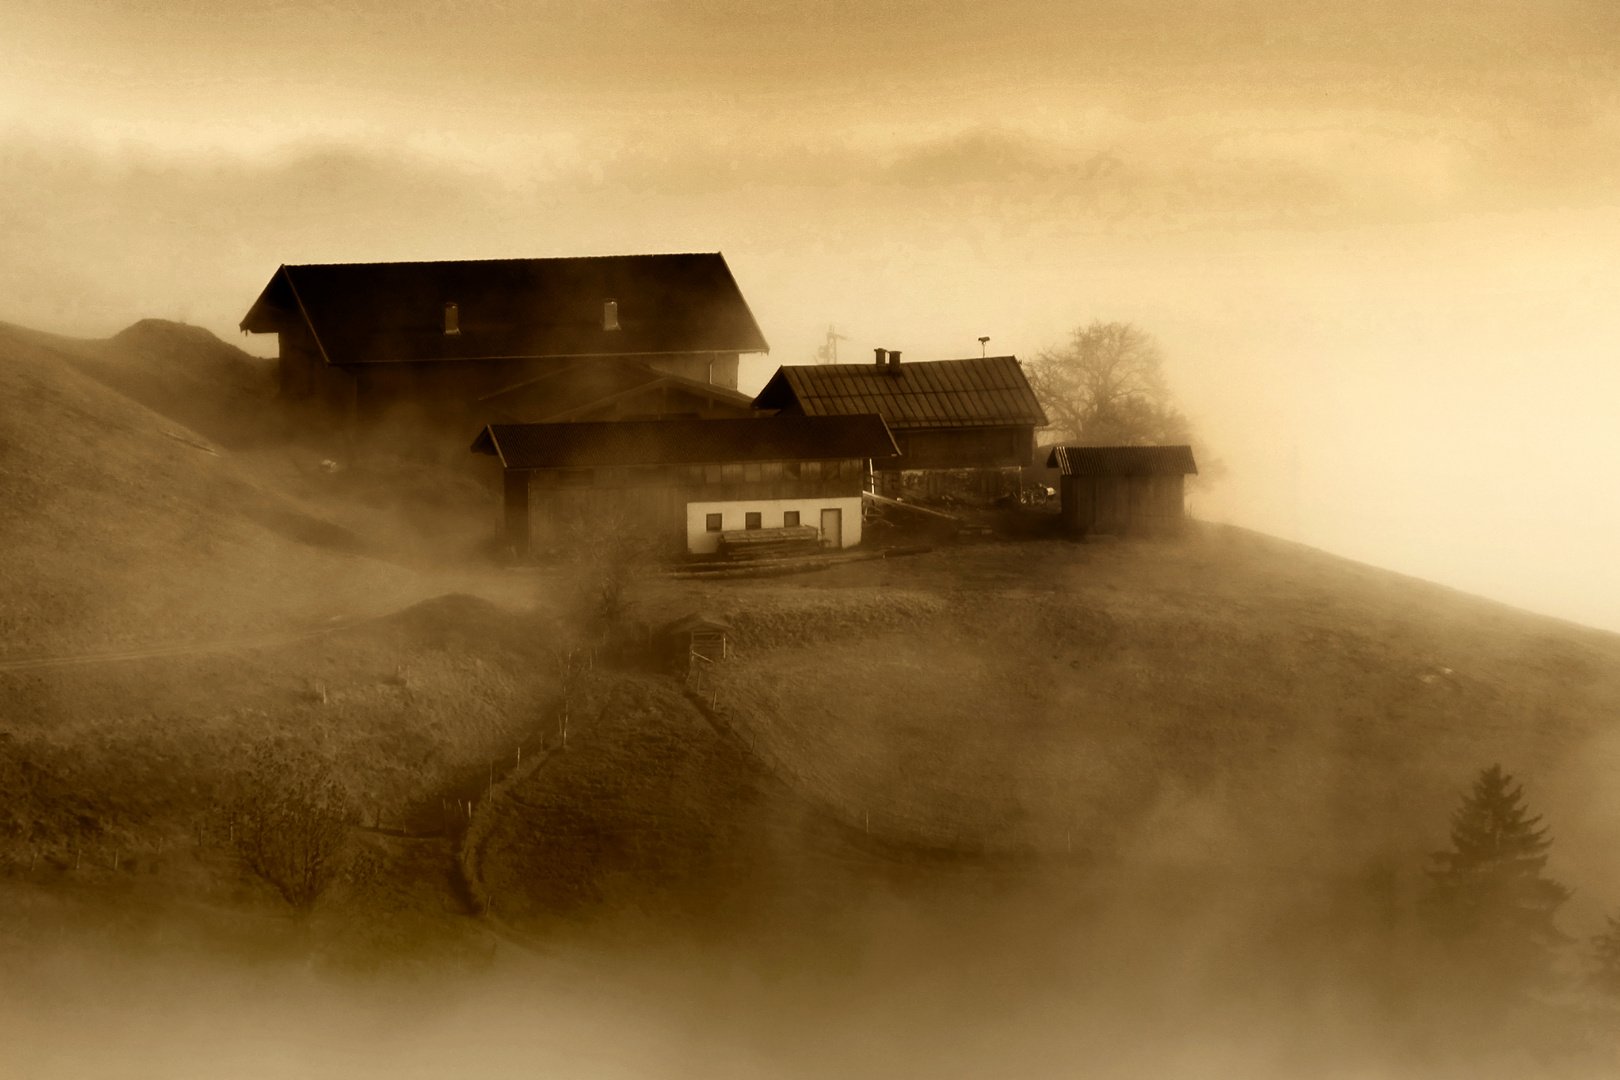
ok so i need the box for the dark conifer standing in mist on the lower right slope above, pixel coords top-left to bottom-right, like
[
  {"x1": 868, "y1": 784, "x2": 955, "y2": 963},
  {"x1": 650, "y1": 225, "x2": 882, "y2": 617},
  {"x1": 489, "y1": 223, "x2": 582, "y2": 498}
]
[{"x1": 1429, "y1": 764, "x2": 1570, "y2": 968}]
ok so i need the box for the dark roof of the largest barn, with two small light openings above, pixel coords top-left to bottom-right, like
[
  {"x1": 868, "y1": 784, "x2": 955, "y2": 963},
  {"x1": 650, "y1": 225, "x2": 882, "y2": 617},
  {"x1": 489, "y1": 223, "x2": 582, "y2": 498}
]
[{"x1": 241, "y1": 253, "x2": 770, "y2": 364}]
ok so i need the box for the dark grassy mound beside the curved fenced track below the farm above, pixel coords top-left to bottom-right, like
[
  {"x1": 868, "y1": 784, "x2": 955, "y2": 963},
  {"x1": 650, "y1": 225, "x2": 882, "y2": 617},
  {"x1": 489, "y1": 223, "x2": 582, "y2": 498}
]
[{"x1": 476, "y1": 675, "x2": 998, "y2": 960}]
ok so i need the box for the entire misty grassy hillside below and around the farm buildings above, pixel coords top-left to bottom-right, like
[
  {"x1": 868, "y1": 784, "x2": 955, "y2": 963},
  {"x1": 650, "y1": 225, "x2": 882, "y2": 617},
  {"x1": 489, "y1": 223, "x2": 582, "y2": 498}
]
[{"x1": 0, "y1": 322, "x2": 1620, "y2": 1078}]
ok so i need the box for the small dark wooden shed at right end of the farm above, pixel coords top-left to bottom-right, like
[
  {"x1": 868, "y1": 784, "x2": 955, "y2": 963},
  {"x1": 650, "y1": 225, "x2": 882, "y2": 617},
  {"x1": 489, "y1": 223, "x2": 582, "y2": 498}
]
[{"x1": 1047, "y1": 447, "x2": 1199, "y2": 536}]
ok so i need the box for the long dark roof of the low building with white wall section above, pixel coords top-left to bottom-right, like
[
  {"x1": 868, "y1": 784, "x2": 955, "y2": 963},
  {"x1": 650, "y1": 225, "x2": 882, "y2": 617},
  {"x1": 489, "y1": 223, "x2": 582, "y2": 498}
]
[{"x1": 473, "y1": 416, "x2": 899, "y2": 468}]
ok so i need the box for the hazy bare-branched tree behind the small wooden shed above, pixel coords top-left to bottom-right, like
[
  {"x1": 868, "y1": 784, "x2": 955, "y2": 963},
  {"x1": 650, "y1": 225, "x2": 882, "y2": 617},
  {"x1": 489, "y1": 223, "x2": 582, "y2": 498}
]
[{"x1": 1025, "y1": 321, "x2": 1192, "y2": 445}]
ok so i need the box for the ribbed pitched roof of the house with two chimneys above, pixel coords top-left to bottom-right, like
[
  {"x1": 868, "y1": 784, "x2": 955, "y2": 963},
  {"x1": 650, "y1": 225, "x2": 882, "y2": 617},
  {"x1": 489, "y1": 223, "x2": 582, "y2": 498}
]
[{"x1": 753, "y1": 356, "x2": 1047, "y2": 431}]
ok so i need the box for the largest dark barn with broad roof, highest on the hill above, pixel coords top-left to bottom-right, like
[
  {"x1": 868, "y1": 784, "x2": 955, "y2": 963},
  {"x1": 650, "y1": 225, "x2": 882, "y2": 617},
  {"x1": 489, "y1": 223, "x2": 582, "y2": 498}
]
[{"x1": 241, "y1": 253, "x2": 770, "y2": 432}]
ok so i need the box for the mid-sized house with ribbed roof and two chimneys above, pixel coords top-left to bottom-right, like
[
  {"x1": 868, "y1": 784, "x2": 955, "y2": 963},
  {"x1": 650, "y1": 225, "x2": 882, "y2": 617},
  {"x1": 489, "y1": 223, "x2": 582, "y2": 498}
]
[{"x1": 753, "y1": 348, "x2": 1047, "y2": 491}]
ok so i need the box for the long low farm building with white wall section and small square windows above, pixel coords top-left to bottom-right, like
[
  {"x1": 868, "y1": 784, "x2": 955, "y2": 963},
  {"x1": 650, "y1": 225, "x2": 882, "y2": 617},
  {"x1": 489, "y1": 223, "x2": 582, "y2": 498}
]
[{"x1": 473, "y1": 415, "x2": 899, "y2": 554}]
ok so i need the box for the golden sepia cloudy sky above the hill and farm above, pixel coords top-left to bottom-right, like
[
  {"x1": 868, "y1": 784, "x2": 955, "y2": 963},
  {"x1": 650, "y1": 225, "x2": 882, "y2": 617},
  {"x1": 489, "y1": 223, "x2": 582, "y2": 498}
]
[{"x1": 9, "y1": 0, "x2": 1620, "y2": 630}]
